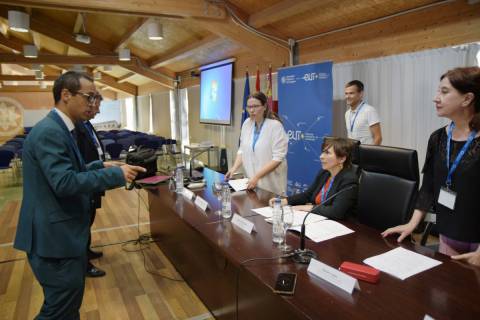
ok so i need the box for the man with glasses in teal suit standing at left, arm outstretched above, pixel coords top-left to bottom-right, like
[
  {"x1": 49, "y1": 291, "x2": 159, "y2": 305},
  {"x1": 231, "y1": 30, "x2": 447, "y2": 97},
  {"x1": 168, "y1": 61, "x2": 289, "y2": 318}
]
[{"x1": 14, "y1": 71, "x2": 144, "y2": 319}]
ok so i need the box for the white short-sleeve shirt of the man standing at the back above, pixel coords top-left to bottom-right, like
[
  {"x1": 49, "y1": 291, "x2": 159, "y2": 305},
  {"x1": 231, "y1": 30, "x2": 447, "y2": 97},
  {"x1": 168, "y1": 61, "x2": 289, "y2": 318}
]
[{"x1": 345, "y1": 102, "x2": 380, "y2": 144}]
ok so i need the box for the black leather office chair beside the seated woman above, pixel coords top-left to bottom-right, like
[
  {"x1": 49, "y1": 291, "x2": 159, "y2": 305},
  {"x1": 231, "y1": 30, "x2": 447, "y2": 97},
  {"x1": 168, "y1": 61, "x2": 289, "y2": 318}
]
[{"x1": 357, "y1": 145, "x2": 419, "y2": 230}]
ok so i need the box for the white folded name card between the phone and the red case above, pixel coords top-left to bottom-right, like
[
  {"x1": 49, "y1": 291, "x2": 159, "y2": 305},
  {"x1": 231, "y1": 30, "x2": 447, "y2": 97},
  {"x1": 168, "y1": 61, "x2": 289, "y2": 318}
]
[{"x1": 307, "y1": 259, "x2": 360, "y2": 294}]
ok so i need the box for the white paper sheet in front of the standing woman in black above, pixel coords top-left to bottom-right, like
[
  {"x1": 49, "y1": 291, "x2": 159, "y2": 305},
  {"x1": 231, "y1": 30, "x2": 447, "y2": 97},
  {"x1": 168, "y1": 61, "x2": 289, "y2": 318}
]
[{"x1": 363, "y1": 247, "x2": 442, "y2": 280}]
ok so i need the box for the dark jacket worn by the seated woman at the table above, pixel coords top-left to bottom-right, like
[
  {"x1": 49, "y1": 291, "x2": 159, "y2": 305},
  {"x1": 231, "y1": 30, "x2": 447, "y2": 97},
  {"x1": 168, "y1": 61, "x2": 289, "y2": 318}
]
[{"x1": 287, "y1": 168, "x2": 358, "y2": 220}]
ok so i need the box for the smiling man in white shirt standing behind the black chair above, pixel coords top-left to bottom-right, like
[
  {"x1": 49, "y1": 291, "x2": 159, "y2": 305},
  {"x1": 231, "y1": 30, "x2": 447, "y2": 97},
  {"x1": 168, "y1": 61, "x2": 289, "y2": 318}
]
[{"x1": 345, "y1": 80, "x2": 382, "y2": 145}]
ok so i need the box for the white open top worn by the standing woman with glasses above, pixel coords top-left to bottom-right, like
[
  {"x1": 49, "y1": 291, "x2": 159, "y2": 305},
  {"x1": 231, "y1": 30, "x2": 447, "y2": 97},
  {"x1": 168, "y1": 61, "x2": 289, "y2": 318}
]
[{"x1": 238, "y1": 118, "x2": 288, "y2": 195}]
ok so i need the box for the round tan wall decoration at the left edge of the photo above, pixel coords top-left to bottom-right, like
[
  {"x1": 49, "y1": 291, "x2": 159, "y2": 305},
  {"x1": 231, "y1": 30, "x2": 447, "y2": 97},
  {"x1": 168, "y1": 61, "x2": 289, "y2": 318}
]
[{"x1": 0, "y1": 97, "x2": 23, "y2": 137}]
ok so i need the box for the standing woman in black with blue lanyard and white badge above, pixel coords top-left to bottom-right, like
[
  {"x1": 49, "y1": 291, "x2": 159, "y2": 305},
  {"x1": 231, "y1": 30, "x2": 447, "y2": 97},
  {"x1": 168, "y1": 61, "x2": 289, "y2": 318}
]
[{"x1": 382, "y1": 67, "x2": 480, "y2": 266}]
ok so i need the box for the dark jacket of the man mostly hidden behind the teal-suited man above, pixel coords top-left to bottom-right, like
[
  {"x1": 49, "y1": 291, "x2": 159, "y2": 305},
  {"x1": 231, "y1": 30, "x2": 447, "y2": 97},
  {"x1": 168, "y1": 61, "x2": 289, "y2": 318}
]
[{"x1": 75, "y1": 122, "x2": 105, "y2": 208}]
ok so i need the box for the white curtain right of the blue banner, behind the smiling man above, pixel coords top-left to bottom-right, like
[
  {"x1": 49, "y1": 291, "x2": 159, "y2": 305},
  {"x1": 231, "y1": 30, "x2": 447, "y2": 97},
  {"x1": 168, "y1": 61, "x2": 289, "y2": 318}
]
[{"x1": 332, "y1": 44, "x2": 480, "y2": 168}]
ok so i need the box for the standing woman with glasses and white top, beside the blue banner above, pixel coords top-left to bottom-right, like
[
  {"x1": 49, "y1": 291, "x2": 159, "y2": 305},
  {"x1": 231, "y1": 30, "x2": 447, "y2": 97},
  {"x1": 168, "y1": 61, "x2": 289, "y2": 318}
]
[{"x1": 225, "y1": 92, "x2": 288, "y2": 195}]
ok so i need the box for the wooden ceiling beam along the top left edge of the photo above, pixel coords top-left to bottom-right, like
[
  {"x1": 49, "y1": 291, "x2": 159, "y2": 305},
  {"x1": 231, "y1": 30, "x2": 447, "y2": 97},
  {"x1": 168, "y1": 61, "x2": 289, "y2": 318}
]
[{"x1": 0, "y1": 0, "x2": 226, "y2": 20}]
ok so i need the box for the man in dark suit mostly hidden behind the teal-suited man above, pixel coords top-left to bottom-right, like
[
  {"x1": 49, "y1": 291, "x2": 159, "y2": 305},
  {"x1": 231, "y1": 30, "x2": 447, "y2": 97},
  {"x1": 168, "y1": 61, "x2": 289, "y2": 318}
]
[{"x1": 75, "y1": 93, "x2": 105, "y2": 277}]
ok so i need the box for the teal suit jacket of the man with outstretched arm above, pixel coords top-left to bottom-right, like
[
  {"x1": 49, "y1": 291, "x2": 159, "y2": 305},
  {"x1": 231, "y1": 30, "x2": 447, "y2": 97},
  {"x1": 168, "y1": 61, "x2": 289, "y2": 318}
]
[{"x1": 14, "y1": 111, "x2": 125, "y2": 258}]
